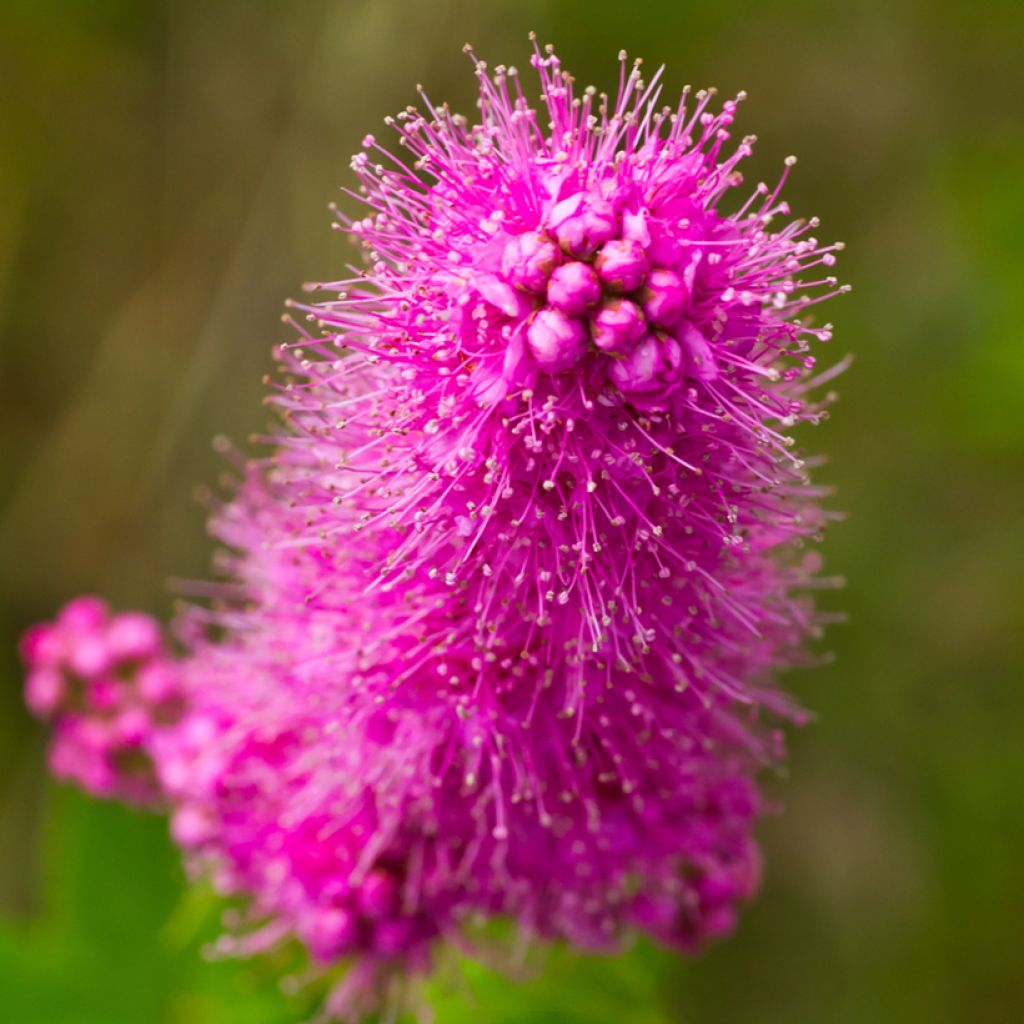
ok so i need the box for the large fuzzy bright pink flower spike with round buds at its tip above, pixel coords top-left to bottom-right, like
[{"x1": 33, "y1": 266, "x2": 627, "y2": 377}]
[{"x1": 19, "y1": 37, "x2": 841, "y2": 1013}]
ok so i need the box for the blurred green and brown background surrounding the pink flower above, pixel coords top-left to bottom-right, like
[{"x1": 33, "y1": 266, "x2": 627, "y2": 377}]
[{"x1": 0, "y1": 0, "x2": 1024, "y2": 1024}]
